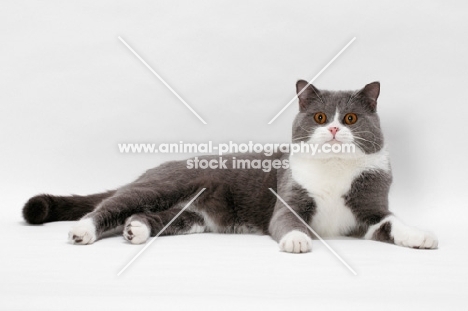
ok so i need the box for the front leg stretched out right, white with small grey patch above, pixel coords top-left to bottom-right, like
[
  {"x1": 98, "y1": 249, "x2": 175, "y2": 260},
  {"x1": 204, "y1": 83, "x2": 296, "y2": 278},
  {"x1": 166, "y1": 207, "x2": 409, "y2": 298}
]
[{"x1": 365, "y1": 215, "x2": 438, "y2": 249}]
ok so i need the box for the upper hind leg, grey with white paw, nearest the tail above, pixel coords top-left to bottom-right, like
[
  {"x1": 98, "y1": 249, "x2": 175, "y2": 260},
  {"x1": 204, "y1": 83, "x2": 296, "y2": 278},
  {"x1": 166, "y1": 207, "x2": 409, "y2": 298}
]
[{"x1": 69, "y1": 161, "x2": 206, "y2": 244}]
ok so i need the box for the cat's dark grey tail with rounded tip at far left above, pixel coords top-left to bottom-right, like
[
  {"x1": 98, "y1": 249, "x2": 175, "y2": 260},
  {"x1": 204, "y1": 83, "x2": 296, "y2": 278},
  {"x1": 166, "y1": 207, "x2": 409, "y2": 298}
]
[{"x1": 23, "y1": 190, "x2": 115, "y2": 225}]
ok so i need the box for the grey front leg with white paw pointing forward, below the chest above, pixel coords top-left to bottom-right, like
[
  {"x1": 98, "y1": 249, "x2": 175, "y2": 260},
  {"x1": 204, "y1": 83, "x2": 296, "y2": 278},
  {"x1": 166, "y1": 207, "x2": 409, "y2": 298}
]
[{"x1": 269, "y1": 186, "x2": 316, "y2": 253}]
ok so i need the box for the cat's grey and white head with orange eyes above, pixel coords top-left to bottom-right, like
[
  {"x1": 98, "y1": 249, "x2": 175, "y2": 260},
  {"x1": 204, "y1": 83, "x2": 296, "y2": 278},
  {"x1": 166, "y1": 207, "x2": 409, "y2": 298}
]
[{"x1": 292, "y1": 80, "x2": 383, "y2": 155}]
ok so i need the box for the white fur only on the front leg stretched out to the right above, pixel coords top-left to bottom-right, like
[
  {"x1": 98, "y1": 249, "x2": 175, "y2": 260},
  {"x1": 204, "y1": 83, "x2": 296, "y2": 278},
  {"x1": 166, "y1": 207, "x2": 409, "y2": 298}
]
[{"x1": 365, "y1": 216, "x2": 439, "y2": 249}]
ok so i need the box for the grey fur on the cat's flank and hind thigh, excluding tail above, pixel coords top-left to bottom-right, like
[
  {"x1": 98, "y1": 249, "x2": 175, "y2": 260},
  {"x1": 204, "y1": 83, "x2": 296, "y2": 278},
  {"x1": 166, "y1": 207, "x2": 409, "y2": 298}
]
[{"x1": 85, "y1": 154, "x2": 281, "y2": 235}]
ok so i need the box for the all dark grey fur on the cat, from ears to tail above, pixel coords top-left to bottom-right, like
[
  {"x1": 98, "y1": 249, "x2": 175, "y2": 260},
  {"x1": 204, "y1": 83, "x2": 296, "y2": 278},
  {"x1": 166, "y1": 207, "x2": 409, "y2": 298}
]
[{"x1": 23, "y1": 80, "x2": 432, "y2": 251}]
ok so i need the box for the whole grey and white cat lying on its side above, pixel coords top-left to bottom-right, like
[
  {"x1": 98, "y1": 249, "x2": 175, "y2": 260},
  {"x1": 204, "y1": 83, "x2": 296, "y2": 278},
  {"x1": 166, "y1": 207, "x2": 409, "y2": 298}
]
[{"x1": 23, "y1": 80, "x2": 438, "y2": 253}]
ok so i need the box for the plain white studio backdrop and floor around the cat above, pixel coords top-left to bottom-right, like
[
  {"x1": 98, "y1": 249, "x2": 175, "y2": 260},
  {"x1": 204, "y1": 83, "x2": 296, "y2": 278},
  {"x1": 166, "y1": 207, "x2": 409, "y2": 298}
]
[{"x1": 0, "y1": 1, "x2": 468, "y2": 310}]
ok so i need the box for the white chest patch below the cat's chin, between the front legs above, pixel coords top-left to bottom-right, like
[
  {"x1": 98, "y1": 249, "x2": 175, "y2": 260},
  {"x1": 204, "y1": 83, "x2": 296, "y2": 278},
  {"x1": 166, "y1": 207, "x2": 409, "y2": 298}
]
[{"x1": 289, "y1": 149, "x2": 390, "y2": 237}]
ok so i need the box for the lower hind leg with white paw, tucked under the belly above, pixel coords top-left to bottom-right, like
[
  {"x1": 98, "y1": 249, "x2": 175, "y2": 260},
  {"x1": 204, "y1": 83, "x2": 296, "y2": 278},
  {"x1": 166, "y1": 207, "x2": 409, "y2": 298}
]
[{"x1": 124, "y1": 208, "x2": 206, "y2": 244}]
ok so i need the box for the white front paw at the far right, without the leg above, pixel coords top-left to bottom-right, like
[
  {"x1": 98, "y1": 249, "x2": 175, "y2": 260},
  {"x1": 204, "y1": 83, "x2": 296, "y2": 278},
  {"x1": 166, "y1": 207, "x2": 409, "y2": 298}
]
[{"x1": 392, "y1": 227, "x2": 439, "y2": 249}]
